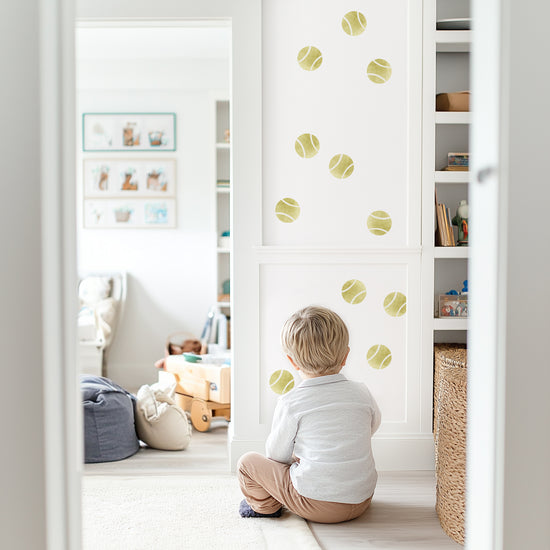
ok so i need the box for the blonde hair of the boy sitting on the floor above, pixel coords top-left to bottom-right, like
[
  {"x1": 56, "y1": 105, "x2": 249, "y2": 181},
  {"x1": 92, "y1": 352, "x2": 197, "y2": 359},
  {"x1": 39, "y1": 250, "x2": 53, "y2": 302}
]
[{"x1": 281, "y1": 306, "x2": 349, "y2": 375}]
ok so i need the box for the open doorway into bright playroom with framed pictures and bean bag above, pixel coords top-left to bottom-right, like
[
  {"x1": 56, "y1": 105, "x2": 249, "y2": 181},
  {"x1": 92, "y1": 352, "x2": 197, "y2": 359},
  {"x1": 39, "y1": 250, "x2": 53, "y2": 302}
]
[{"x1": 76, "y1": 21, "x2": 231, "y2": 474}]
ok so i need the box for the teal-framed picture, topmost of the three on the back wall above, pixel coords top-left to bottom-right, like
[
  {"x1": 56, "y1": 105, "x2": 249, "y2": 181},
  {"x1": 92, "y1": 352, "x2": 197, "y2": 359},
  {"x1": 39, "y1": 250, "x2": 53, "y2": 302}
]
[{"x1": 82, "y1": 113, "x2": 176, "y2": 151}]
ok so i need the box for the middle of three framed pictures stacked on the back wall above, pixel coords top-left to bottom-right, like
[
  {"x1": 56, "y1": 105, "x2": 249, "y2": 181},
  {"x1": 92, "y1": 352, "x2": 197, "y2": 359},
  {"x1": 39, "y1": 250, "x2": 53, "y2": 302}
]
[{"x1": 82, "y1": 158, "x2": 176, "y2": 198}]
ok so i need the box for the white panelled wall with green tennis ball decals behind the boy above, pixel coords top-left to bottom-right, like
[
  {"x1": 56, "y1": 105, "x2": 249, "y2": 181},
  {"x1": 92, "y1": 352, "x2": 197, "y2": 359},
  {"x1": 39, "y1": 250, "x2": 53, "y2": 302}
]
[{"x1": 233, "y1": 0, "x2": 433, "y2": 469}]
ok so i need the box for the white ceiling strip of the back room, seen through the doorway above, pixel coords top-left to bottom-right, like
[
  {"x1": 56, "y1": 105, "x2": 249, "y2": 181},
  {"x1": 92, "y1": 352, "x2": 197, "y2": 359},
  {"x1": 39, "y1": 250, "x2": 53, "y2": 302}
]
[{"x1": 76, "y1": 24, "x2": 231, "y2": 60}]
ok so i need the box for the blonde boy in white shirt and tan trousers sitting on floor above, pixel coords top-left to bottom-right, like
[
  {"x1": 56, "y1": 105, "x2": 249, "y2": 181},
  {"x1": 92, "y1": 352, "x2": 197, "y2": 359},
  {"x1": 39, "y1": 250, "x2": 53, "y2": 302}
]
[{"x1": 238, "y1": 306, "x2": 380, "y2": 523}]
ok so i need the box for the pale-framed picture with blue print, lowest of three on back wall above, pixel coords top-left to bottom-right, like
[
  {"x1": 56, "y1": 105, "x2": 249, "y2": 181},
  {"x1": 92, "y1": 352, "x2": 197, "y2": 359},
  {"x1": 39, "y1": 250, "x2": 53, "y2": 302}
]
[{"x1": 84, "y1": 198, "x2": 176, "y2": 229}]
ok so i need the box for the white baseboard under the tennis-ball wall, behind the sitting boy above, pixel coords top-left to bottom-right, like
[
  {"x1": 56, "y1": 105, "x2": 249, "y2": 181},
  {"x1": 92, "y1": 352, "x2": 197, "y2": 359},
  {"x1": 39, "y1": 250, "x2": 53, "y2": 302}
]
[{"x1": 228, "y1": 433, "x2": 435, "y2": 472}]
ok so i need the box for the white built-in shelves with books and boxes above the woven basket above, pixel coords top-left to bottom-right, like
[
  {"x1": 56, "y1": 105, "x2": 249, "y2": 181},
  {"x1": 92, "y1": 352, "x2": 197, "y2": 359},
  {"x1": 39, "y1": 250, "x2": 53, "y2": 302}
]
[{"x1": 422, "y1": 0, "x2": 472, "y2": 360}]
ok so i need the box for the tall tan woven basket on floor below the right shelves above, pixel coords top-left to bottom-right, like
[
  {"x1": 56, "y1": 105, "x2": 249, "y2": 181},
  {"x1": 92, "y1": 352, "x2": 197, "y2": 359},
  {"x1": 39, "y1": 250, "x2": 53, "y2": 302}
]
[{"x1": 434, "y1": 350, "x2": 467, "y2": 543}]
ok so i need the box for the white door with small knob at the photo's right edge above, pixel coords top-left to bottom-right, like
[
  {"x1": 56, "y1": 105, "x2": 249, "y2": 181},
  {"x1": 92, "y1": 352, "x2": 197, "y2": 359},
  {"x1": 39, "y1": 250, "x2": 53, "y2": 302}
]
[{"x1": 466, "y1": 0, "x2": 550, "y2": 550}]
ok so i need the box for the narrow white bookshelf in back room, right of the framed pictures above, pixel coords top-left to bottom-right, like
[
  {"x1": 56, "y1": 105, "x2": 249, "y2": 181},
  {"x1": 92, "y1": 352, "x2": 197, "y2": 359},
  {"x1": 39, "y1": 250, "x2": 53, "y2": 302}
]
[{"x1": 214, "y1": 97, "x2": 231, "y2": 336}]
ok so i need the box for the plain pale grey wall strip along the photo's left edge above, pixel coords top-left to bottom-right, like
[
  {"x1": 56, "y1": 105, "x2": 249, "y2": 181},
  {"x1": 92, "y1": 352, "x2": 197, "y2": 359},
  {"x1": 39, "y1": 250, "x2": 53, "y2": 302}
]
[{"x1": 0, "y1": 0, "x2": 46, "y2": 550}]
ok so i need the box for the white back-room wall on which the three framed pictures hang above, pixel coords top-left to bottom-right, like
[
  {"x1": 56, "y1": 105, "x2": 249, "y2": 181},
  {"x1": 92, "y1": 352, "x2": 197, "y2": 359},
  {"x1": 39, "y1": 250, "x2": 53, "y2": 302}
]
[{"x1": 77, "y1": 54, "x2": 229, "y2": 388}]
